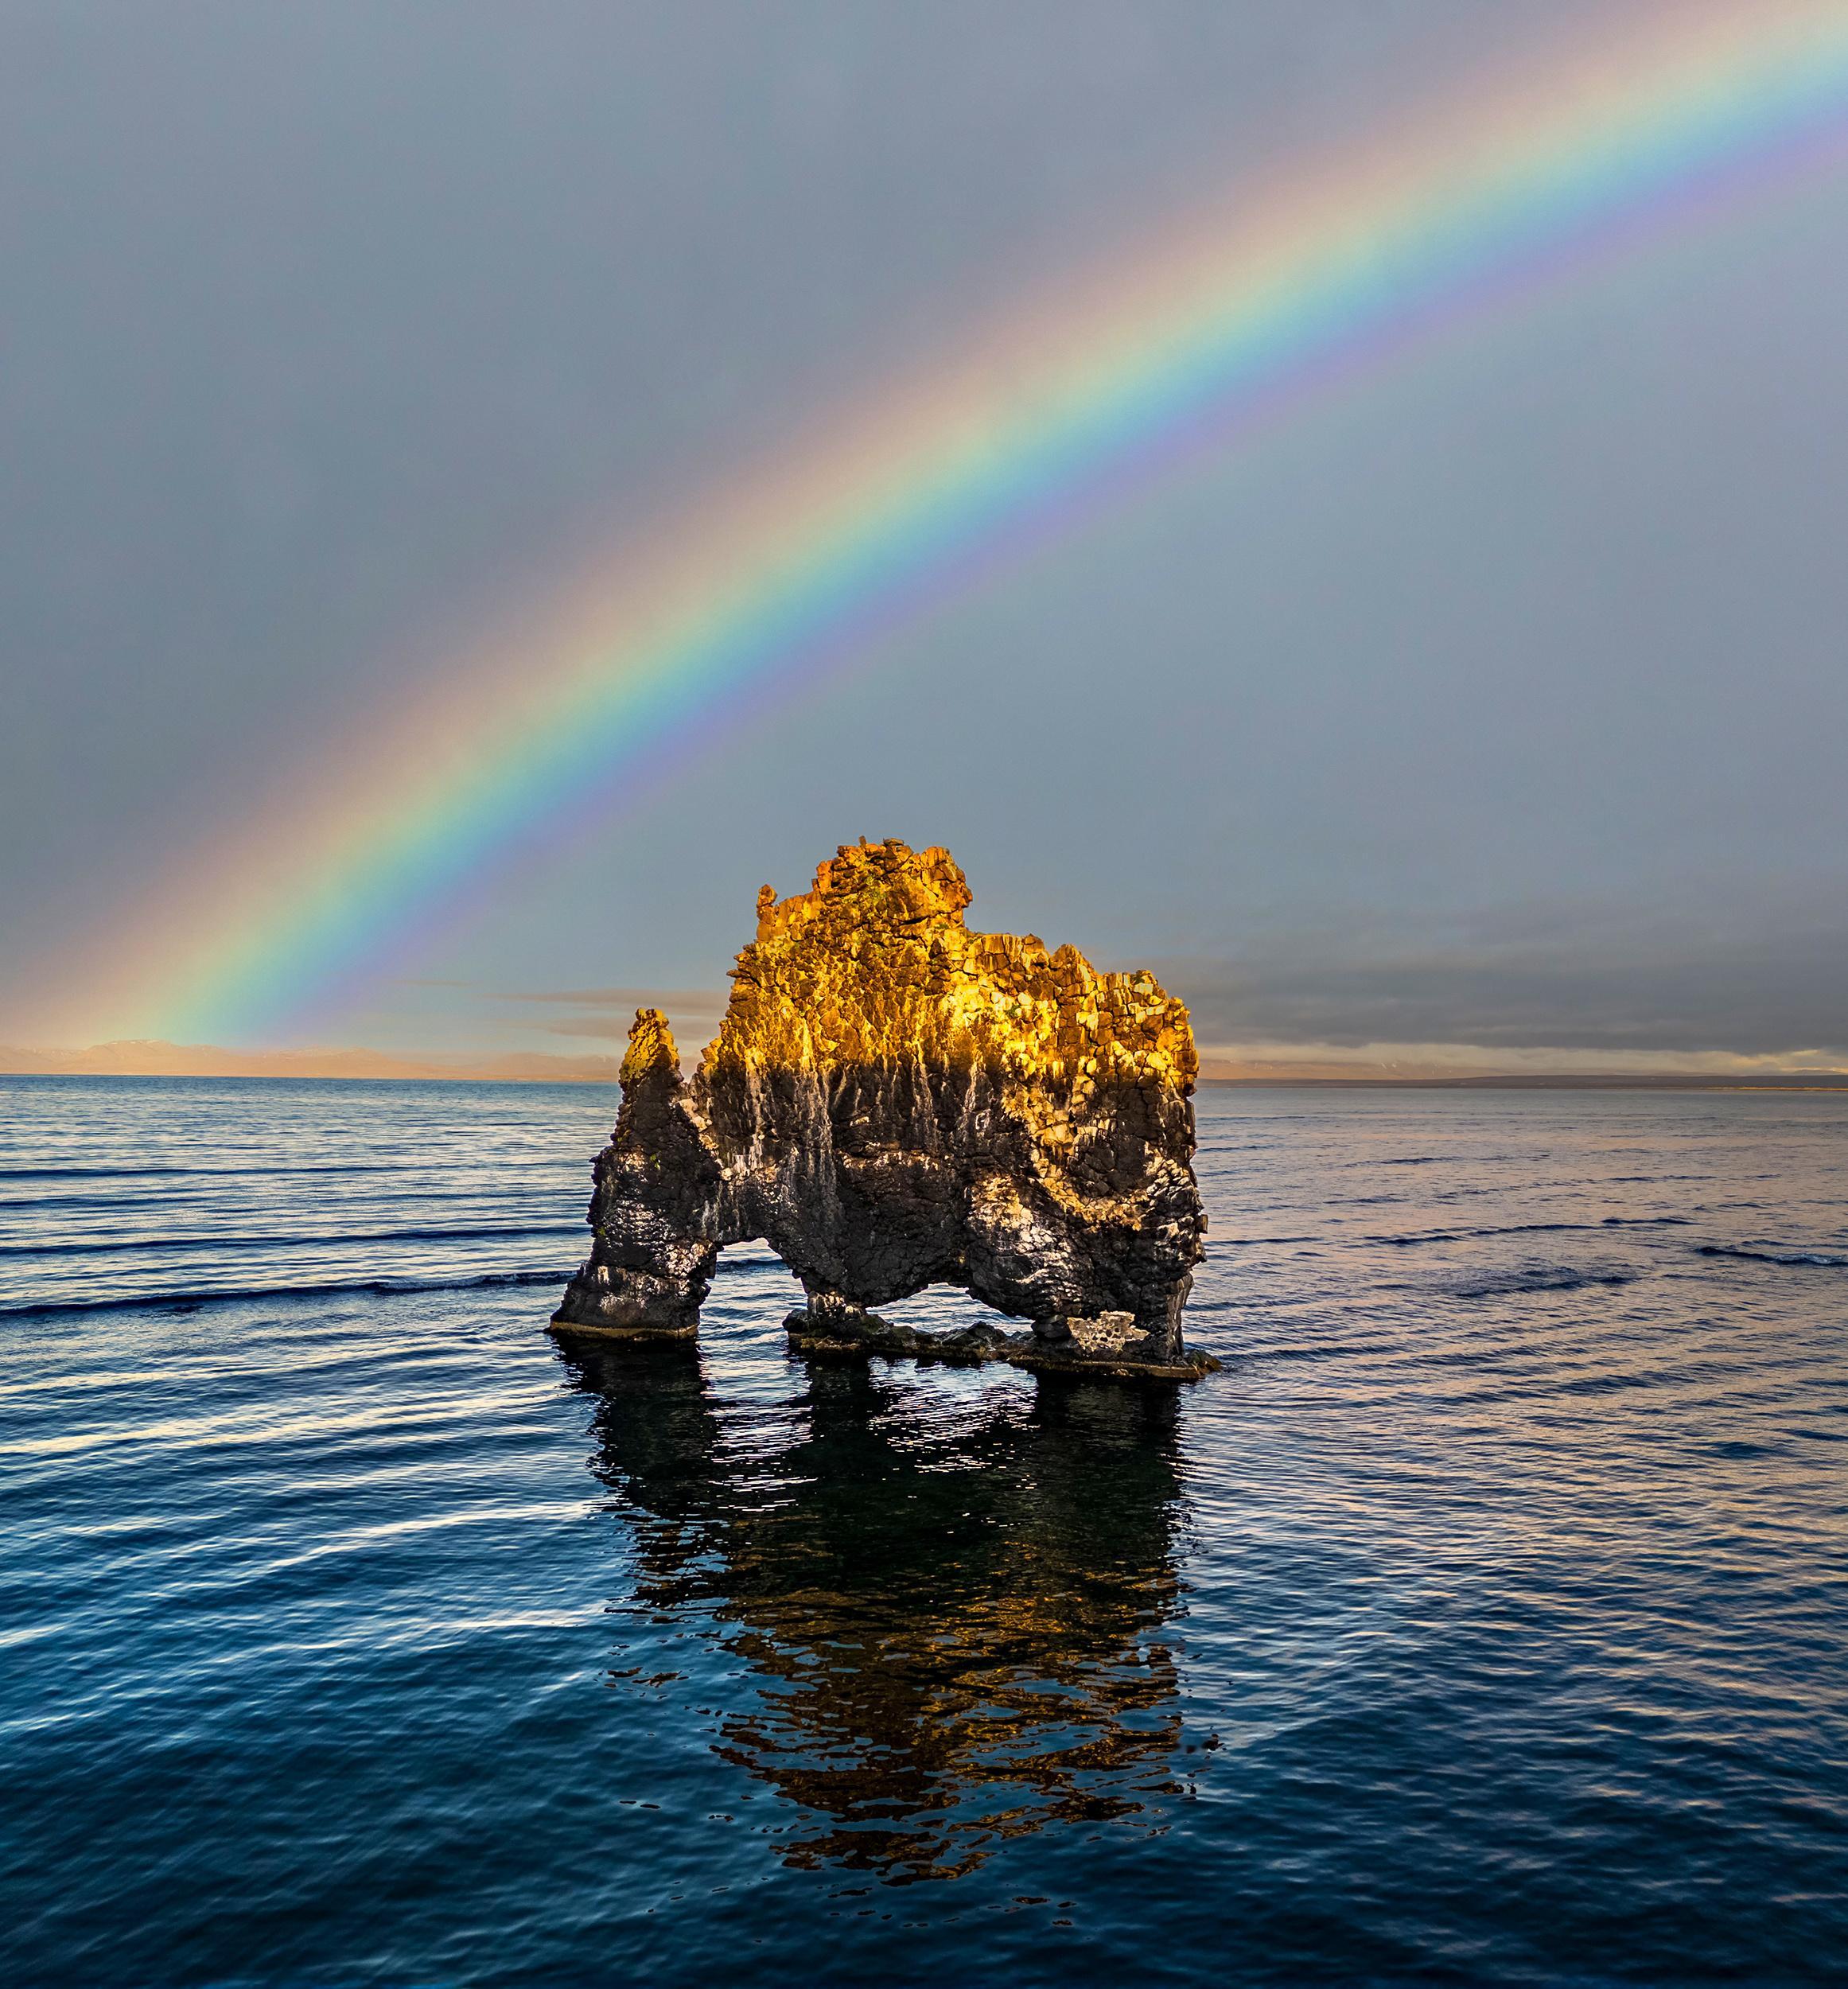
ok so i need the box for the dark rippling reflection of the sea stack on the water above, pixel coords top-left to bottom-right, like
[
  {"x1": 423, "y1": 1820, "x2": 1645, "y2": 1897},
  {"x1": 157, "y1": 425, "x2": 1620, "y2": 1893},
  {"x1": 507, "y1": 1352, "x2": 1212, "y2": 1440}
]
[{"x1": 575, "y1": 1351, "x2": 1180, "y2": 1882}]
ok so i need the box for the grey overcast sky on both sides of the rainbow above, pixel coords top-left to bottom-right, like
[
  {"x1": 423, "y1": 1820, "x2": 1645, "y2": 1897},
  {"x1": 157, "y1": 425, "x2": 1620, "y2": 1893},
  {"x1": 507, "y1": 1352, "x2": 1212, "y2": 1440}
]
[{"x1": 0, "y1": 0, "x2": 1848, "y2": 1061}]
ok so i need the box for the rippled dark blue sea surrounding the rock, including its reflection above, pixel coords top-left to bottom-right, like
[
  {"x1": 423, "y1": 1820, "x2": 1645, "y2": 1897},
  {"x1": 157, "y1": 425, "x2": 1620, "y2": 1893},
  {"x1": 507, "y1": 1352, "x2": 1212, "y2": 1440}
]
[{"x1": 0, "y1": 1078, "x2": 1848, "y2": 1985}]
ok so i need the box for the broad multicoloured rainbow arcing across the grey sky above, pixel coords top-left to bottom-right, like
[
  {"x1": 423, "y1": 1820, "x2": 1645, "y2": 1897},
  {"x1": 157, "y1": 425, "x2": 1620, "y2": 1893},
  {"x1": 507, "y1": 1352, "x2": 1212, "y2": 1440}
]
[{"x1": 111, "y1": 0, "x2": 1848, "y2": 1042}]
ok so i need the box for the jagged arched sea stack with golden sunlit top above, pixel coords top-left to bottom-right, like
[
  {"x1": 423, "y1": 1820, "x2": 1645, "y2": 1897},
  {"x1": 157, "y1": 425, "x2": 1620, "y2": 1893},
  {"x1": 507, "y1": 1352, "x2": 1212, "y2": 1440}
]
[{"x1": 553, "y1": 842, "x2": 1216, "y2": 1379}]
